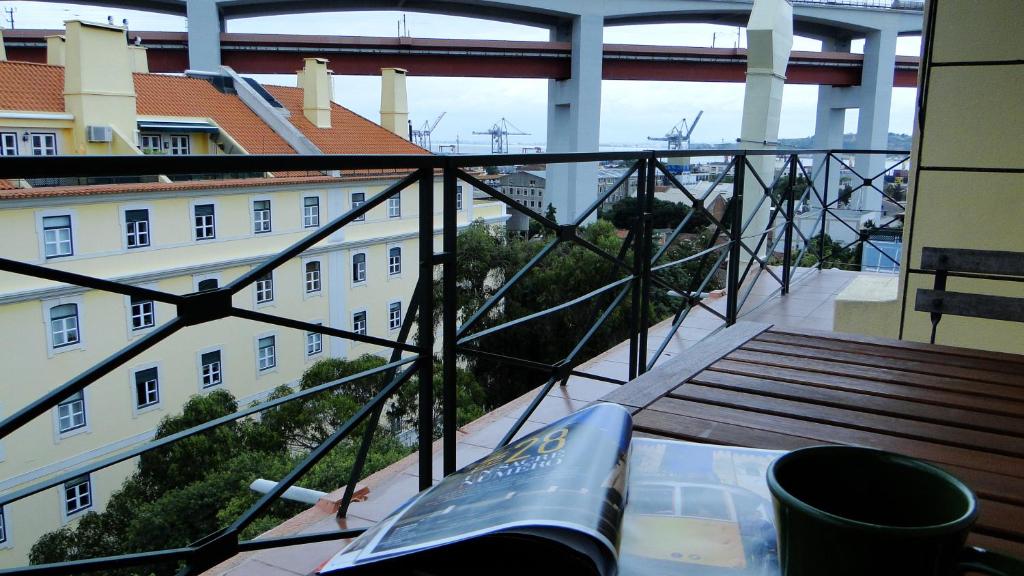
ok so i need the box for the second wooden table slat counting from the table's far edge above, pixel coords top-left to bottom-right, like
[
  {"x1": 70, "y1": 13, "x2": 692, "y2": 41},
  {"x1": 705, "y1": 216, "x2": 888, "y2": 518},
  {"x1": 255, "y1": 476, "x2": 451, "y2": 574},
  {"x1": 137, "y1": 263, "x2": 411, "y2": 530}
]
[{"x1": 726, "y1": 349, "x2": 1024, "y2": 402}]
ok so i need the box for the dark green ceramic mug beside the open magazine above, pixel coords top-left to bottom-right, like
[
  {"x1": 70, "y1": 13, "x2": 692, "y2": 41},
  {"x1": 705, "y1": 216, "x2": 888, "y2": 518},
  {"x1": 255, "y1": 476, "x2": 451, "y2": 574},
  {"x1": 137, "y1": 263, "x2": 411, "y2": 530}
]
[{"x1": 768, "y1": 446, "x2": 1024, "y2": 576}]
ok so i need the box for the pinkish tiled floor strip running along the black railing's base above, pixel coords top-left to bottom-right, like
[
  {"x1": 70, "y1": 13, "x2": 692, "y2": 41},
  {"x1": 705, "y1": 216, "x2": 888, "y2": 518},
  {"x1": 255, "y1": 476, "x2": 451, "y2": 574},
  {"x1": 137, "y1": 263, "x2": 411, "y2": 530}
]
[{"x1": 209, "y1": 270, "x2": 861, "y2": 576}]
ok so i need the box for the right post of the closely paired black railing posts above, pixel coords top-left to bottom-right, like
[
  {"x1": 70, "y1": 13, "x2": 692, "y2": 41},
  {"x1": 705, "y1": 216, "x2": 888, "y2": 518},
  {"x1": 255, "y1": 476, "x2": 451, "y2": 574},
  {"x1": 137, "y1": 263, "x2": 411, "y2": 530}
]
[{"x1": 441, "y1": 159, "x2": 456, "y2": 476}]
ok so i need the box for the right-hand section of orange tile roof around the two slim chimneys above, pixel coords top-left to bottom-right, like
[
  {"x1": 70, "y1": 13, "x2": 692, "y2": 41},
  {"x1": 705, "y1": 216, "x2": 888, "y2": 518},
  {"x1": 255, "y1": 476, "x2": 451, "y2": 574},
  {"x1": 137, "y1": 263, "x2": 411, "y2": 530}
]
[{"x1": 264, "y1": 85, "x2": 430, "y2": 154}]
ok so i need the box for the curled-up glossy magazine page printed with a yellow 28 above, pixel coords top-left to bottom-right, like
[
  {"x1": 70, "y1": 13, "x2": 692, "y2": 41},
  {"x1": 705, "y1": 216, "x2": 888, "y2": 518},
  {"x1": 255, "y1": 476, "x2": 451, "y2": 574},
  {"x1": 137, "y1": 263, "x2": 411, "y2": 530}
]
[{"x1": 322, "y1": 404, "x2": 631, "y2": 573}]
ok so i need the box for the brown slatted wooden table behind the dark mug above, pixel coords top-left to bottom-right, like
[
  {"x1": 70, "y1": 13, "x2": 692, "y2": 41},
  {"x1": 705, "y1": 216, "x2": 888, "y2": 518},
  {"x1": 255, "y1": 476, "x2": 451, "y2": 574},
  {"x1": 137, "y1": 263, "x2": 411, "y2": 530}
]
[{"x1": 603, "y1": 322, "x2": 1024, "y2": 558}]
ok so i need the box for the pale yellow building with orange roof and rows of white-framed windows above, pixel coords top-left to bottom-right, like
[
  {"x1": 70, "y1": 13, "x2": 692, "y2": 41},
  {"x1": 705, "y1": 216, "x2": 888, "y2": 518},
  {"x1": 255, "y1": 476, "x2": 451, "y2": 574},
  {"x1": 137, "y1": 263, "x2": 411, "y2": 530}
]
[{"x1": 0, "y1": 23, "x2": 505, "y2": 567}]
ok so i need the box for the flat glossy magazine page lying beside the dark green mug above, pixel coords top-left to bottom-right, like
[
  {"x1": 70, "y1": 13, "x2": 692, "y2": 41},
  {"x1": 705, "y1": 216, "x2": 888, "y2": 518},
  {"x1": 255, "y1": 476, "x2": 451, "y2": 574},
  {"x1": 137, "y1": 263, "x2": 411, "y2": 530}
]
[{"x1": 618, "y1": 438, "x2": 784, "y2": 576}]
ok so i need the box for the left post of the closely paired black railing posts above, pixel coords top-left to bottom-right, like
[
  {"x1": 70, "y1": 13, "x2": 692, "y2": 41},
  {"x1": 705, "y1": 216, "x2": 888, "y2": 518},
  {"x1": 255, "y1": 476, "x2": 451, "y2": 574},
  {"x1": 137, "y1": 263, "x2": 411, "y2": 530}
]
[{"x1": 416, "y1": 168, "x2": 434, "y2": 490}]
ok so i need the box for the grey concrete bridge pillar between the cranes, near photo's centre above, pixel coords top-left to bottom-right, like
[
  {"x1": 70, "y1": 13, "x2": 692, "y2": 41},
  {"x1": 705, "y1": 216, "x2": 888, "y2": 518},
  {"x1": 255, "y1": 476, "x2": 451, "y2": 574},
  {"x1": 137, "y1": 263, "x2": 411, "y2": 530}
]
[{"x1": 540, "y1": 14, "x2": 604, "y2": 223}]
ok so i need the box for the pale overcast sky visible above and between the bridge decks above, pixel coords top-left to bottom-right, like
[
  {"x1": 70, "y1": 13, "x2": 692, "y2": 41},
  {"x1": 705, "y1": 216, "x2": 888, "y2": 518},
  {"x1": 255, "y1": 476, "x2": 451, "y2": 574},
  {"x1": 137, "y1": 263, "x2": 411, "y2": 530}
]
[{"x1": 0, "y1": 1, "x2": 921, "y2": 152}]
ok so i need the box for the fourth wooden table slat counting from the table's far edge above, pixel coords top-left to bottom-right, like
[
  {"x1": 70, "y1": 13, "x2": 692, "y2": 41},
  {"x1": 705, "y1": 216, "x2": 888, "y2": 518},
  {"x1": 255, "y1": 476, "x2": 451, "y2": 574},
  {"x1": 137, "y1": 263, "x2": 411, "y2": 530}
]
[{"x1": 669, "y1": 383, "x2": 1024, "y2": 455}]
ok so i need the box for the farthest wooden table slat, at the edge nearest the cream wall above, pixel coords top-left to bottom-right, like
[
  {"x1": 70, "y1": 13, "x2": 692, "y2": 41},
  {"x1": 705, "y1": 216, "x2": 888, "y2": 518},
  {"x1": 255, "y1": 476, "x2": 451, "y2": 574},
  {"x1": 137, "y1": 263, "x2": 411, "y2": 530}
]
[{"x1": 756, "y1": 330, "x2": 1024, "y2": 375}]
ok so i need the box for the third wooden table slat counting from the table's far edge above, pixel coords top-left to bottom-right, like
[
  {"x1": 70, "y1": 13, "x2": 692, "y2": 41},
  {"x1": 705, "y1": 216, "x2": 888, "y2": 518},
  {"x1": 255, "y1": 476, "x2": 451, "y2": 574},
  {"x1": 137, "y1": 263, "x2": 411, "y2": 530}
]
[{"x1": 677, "y1": 365, "x2": 1024, "y2": 437}]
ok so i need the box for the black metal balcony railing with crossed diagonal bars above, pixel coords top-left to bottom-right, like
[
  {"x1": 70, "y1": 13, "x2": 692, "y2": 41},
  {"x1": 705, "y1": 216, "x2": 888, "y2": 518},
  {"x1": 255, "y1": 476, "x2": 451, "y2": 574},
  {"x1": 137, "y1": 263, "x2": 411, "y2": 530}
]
[{"x1": 0, "y1": 151, "x2": 907, "y2": 574}]
